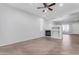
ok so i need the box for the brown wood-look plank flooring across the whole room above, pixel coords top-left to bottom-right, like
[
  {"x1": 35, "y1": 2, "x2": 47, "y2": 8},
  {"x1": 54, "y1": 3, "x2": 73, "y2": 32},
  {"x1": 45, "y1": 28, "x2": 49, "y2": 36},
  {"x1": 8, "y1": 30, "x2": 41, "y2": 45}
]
[{"x1": 0, "y1": 35, "x2": 79, "y2": 55}]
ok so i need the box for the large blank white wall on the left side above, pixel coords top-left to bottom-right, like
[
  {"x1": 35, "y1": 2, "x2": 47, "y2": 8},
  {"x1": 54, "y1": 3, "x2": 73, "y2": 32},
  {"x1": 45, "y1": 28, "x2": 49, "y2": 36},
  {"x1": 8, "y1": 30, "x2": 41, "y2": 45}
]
[{"x1": 0, "y1": 4, "x2": 43, "y2": 46}]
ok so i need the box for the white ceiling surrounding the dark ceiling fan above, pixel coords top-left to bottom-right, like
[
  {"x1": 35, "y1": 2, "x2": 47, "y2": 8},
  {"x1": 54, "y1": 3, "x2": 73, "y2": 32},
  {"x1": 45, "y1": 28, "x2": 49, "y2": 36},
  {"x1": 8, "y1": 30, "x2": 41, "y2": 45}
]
[{"x1": 8, "y1": 3, "x2": 79, "y2": 20}]
